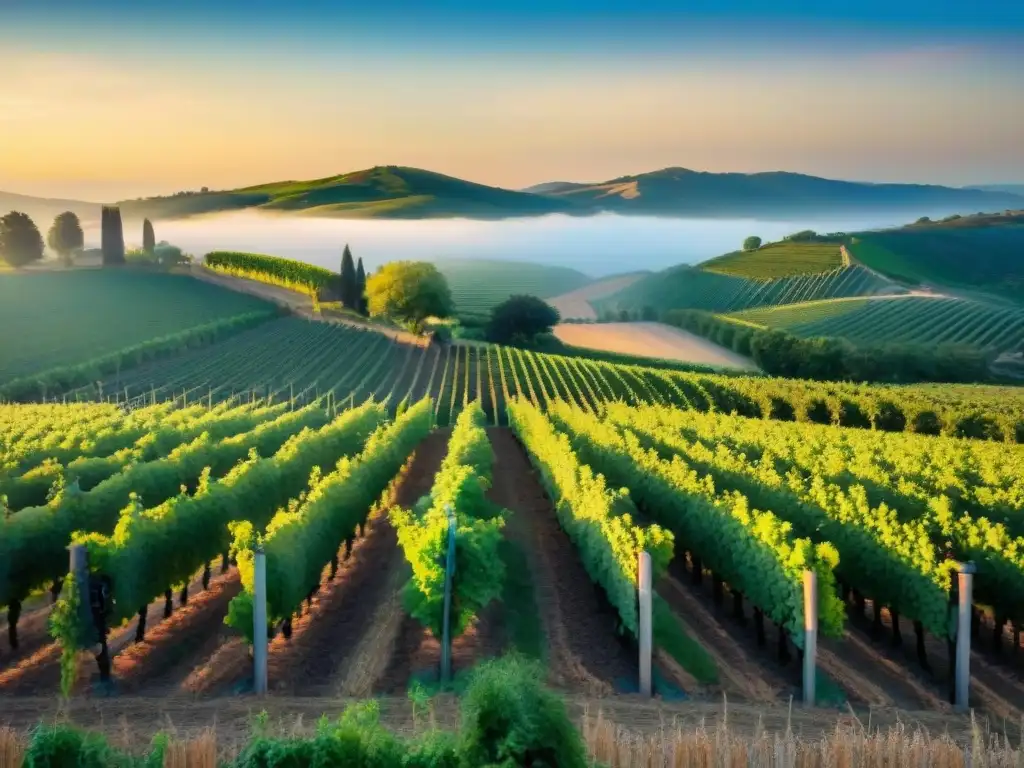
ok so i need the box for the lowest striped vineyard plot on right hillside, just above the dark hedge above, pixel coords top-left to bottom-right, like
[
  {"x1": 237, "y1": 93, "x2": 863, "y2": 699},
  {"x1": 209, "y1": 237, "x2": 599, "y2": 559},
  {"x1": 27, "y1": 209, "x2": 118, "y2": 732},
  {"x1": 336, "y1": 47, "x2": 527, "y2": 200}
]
[{"x1": 732, "y1": 296, "x2": 1024, "y2": 351}]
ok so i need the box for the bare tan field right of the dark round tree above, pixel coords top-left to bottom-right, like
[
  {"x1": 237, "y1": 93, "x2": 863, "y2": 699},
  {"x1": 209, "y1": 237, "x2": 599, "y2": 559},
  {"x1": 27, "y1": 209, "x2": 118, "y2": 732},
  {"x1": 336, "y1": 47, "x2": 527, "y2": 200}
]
[{"x1": 554, "y1": 323, "x2": 757, "y2": 371}]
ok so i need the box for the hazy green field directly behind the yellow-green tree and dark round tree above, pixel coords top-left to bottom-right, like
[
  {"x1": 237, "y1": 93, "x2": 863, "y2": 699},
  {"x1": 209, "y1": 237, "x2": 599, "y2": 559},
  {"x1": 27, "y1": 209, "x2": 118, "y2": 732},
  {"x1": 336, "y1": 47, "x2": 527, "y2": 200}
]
[{"x1": 436, "y1": 259, "x2": 591, "y2": 317}]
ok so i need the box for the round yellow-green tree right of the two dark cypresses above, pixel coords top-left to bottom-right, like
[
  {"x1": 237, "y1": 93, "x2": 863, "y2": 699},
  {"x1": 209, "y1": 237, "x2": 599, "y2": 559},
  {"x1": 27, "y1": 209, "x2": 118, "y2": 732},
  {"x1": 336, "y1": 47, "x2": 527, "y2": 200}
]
[{"x1": 367, "y1": 261, "x2": 455, "y2": 331}]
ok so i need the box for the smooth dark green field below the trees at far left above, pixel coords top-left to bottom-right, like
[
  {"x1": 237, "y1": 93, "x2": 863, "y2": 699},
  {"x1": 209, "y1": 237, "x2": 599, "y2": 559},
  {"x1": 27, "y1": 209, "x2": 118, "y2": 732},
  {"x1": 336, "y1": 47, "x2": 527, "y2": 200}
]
[{"x1": 0, "y1": 269, "x2": 271, "y2": 384}]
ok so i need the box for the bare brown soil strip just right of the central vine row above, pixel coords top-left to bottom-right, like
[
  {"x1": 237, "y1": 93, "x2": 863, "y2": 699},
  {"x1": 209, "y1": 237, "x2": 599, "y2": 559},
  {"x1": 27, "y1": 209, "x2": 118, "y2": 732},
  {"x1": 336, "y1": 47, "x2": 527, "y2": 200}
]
[{"x1": 488, "y1": 428, "x2": 637, "y2": 695}]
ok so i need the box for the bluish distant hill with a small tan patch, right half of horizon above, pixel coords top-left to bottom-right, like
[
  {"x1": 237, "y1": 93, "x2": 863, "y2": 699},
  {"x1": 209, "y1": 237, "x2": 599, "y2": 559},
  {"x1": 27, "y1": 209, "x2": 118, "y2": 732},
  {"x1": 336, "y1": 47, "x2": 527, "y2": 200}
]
[{"x1": 525, "y1": 168, "x2": 1024, "y2": 216}]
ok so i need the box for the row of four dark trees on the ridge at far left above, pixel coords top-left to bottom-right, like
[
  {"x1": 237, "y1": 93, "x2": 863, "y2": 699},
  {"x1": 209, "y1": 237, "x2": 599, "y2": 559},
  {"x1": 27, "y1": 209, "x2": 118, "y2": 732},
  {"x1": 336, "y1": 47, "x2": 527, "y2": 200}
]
[{"x1": 0, "y1": 206, "x2": 157, "y2": 267}]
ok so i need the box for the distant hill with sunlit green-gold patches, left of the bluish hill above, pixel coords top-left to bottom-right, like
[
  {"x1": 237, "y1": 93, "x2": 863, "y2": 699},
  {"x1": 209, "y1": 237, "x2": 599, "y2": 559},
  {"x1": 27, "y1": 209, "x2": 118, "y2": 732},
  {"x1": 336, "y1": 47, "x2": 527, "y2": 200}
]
[{"x1": 120, "y1": 166, "x2": 571, "y2": 219}]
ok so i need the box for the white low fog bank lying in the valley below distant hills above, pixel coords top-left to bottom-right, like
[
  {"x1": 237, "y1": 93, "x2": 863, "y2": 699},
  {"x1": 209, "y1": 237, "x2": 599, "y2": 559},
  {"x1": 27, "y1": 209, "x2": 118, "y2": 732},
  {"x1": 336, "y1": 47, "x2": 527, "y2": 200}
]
[{"x1": 86, "y1": 211, "x2": 934, "y2": 278}]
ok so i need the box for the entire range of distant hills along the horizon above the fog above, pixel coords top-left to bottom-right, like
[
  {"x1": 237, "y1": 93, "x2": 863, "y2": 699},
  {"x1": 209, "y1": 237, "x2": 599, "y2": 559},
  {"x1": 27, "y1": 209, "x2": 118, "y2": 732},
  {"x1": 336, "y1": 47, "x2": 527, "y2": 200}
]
[{"x1": 8, "y1": 166, "x2": 1003, "y2": 220}]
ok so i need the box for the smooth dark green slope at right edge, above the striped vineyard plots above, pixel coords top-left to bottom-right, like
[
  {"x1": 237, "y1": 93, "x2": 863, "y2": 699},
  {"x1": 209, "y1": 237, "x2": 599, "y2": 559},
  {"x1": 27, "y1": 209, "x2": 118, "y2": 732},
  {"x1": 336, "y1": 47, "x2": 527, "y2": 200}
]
[{"x1": 848, "y1": 223, "x2": 1024, "y2": 302}]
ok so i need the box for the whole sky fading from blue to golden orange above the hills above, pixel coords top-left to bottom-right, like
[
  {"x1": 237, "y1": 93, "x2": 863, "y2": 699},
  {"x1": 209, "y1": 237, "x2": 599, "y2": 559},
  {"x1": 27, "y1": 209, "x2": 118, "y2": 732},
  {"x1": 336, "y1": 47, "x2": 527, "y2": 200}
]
[{"x1": 0, "y1": 0, "x2": 1024, "y2": 201}]
